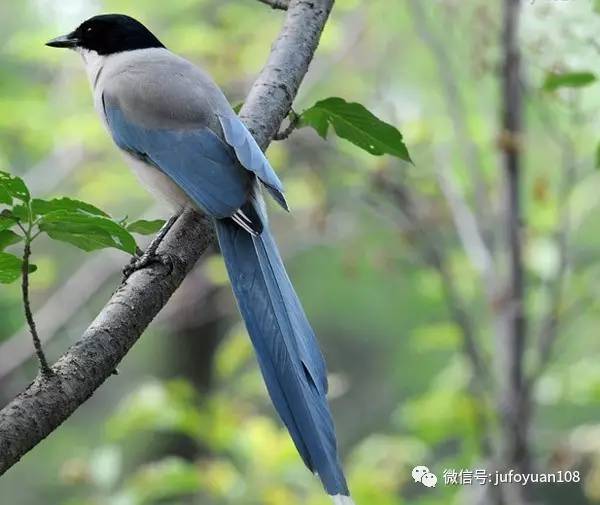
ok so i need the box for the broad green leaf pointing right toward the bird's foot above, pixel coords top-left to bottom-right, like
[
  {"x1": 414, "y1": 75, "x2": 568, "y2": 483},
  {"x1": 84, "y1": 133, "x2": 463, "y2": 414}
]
[{"x1": 39, "y1": 210, "x2": 136, "y2": 254}]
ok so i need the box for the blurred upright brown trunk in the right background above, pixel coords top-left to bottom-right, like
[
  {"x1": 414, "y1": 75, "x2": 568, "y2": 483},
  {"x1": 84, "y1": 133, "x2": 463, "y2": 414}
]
[{"x1": 496, "y1": 0, "x2": 531, "y2": 505}]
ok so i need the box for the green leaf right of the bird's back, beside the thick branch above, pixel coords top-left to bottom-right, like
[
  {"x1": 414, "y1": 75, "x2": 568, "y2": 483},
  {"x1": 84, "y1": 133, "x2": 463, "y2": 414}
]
[{"x1": 298, "y1": 97, "x2": 412, "y2": 163}]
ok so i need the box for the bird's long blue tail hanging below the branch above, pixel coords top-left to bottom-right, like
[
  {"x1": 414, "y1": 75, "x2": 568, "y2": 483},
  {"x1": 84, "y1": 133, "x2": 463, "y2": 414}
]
[{"x1": 216, "y1": 212, "x2": 352, "y2": 496}]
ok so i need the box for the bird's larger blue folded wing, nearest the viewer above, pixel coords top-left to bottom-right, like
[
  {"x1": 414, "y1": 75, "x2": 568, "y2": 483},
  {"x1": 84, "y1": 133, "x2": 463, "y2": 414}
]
[{"x1": 104, "y1": 99, "x2": 253, "y2": 218}]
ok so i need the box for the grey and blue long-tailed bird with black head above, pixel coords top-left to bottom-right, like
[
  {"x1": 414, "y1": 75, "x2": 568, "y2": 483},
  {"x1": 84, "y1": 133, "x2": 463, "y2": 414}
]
[{"x1": 46, "y1": 14, "x2": 354, "y2": 505}]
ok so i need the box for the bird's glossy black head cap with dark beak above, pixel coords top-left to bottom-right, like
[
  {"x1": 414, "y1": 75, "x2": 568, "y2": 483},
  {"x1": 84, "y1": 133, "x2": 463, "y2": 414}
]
[{"x1": 46, "y1": 14, "x2": 165, "y2": 56}]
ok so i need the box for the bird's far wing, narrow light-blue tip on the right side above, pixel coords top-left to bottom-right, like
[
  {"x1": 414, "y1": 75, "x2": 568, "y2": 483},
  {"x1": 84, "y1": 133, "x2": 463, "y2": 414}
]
[{"x1": 217, "y1": 114, "x2": 289, "y2": 210}]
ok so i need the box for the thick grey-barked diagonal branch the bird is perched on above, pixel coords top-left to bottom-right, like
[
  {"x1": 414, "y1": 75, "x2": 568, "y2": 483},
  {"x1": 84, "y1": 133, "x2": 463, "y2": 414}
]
[{"x1": 0, "y1": 0, "x2": 334, "y2": 474}]
